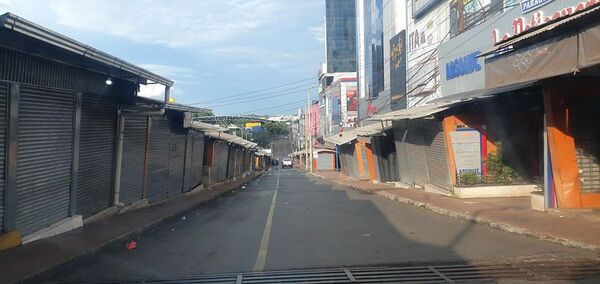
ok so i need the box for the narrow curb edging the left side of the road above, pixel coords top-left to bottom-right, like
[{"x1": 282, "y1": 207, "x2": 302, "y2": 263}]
[{"x1": 21, "y1": 171, "x2": 265, "y2": 284}]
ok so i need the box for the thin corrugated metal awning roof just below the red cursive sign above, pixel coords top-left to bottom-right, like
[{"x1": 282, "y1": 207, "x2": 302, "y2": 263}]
[{"x1": 479, "y1": 3, "x2": 600, "y2": 57}]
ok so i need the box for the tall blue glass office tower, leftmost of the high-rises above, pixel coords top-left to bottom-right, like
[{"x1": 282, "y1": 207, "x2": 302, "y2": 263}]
[{"x1": 325, "y1": 0, "x2": 356, "y2": 73}]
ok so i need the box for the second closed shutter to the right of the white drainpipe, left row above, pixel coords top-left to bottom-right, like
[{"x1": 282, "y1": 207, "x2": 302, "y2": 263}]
[{"x1": 147, "y1": 117, "x2": 171, "y2": 202}]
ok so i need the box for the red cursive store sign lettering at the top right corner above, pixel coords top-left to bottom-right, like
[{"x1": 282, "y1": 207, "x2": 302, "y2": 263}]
[{"x1": 492, "y1": 0, "x2": 600, "y2": 45}]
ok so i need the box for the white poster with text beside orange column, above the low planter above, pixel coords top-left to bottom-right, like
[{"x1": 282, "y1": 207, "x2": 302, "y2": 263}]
[{"x1": 450, "y1": 128, "x2": 481, "y2": 176}]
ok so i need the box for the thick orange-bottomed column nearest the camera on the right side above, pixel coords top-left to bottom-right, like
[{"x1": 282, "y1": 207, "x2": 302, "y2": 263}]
[{"x1": 542, "y1": 80, "x2": 581, "y2": 208}]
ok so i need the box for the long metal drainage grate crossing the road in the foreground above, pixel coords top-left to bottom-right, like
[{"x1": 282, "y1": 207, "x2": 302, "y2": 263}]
[{"x1": 50, "y1": 260, "x2": 600, "y2": 284}]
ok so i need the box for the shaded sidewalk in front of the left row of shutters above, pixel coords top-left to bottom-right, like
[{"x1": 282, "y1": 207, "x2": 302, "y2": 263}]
[{"x1": 0, "y1": 172, "x2": 262, "y2": 283}]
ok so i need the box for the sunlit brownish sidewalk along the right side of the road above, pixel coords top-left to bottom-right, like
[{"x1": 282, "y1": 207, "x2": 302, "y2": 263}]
[{"x1": 313, "y1": 171, "x2": 600, "y2": 251}]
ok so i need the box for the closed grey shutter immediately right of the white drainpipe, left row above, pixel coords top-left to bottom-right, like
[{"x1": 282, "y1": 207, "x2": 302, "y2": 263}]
[{"x1": 119, "y1": 115, "x2": 148, "y2": 204}]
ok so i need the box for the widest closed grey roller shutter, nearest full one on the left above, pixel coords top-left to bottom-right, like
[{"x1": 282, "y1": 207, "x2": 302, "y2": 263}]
[{"x1": 16, "y1": 86, "x2": 75, "y2": 235}]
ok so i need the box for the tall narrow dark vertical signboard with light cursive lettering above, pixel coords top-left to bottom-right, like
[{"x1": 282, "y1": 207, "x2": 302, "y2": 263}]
[{"x1": 390, "y1": 30, "x2": 406, "y2": 111}]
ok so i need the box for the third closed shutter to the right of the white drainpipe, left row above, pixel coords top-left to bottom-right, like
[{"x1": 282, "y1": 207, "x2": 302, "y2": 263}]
[{"x1": 168, "y1": 129, "x2": 186, "y2": 197}]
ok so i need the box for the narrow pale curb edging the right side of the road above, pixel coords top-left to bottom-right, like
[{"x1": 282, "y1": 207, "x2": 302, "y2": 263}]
[{"x1": 309, "y1": 173, "x2": 600, "y2": 252}]
